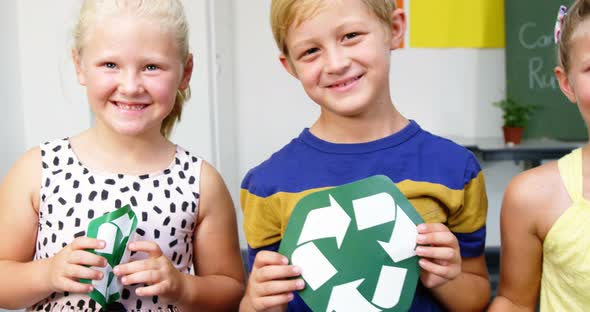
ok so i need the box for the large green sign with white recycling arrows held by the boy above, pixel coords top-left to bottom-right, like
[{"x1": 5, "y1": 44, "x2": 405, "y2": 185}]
[{"x1": 279, "y1": 175, "x2": 423, "y2": 312}]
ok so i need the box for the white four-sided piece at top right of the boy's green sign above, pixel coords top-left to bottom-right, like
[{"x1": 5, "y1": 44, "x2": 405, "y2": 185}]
[{"x1": 352, "y1": 192, "x2": 395, "y2": 231}]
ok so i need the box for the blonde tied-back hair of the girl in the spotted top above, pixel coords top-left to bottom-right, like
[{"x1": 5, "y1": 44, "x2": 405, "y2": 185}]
[{"x1": 73, "y1": 0, "x2": 190, "y2": 137}]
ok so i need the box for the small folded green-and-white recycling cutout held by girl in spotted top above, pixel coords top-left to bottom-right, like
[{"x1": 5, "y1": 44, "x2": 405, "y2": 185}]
[{"x1": 80, "y1": 205, "x2": 137, "y2": 307}]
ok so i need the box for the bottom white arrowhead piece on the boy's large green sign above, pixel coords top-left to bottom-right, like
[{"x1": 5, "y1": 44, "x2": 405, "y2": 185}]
[{"x1": 326, "y1": 278, "x2": 381, "y2": 312}]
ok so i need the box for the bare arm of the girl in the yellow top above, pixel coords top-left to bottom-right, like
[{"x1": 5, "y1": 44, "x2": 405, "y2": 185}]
[{"x1": 490, "y1": 173, "x2": 544, "y2": 311}]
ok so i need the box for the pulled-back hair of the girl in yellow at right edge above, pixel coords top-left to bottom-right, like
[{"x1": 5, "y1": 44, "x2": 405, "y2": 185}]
[{"x1": 557, "y1": 0, "x2": 590, "y2": 73}]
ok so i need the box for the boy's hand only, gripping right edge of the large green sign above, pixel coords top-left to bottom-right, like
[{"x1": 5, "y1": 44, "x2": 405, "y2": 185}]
[{"x1": 416, "y1": 223, "x2": 461, "y2": 288}]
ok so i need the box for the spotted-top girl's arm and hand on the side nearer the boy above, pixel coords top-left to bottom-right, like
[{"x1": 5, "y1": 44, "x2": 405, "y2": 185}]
[{"x1": 115, "y1": 162, "x2": 244, "y2": 311}]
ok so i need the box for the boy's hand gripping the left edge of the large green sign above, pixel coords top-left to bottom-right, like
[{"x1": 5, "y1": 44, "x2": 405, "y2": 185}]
[{"x1": 241, "y1": 250, "x2": 305, "y2": 311}]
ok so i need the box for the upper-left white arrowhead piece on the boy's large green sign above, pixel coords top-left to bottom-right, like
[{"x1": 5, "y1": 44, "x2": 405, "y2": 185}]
[{"x1": 297, "y1": 195, "x2": 350, "y2": 248}]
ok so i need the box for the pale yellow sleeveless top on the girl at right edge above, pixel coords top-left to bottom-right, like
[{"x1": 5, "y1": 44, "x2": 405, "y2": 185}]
[{"x1": 541, "y1": 149, "x2": 590, "y2": 311}]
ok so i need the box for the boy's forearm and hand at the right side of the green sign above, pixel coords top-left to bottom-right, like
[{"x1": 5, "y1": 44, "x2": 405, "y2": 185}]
[{"x1": 416, "y1": 223, "x2": 490, "y2": 311}]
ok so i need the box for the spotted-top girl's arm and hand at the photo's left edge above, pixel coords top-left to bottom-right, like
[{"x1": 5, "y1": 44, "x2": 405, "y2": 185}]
[{"x1": 0, "y1": 148, "x2": 105, "y2": 309}]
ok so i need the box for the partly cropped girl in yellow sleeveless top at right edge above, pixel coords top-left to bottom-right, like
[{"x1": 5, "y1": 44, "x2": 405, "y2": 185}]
[{"x1": 490, "y1": 0, "x2": 590, "y2": 311}]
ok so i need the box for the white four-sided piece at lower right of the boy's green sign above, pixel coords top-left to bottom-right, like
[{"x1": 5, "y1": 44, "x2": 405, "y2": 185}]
[{"x1": 372, "y1": 265, "x2": 408, "y2": 309}]
